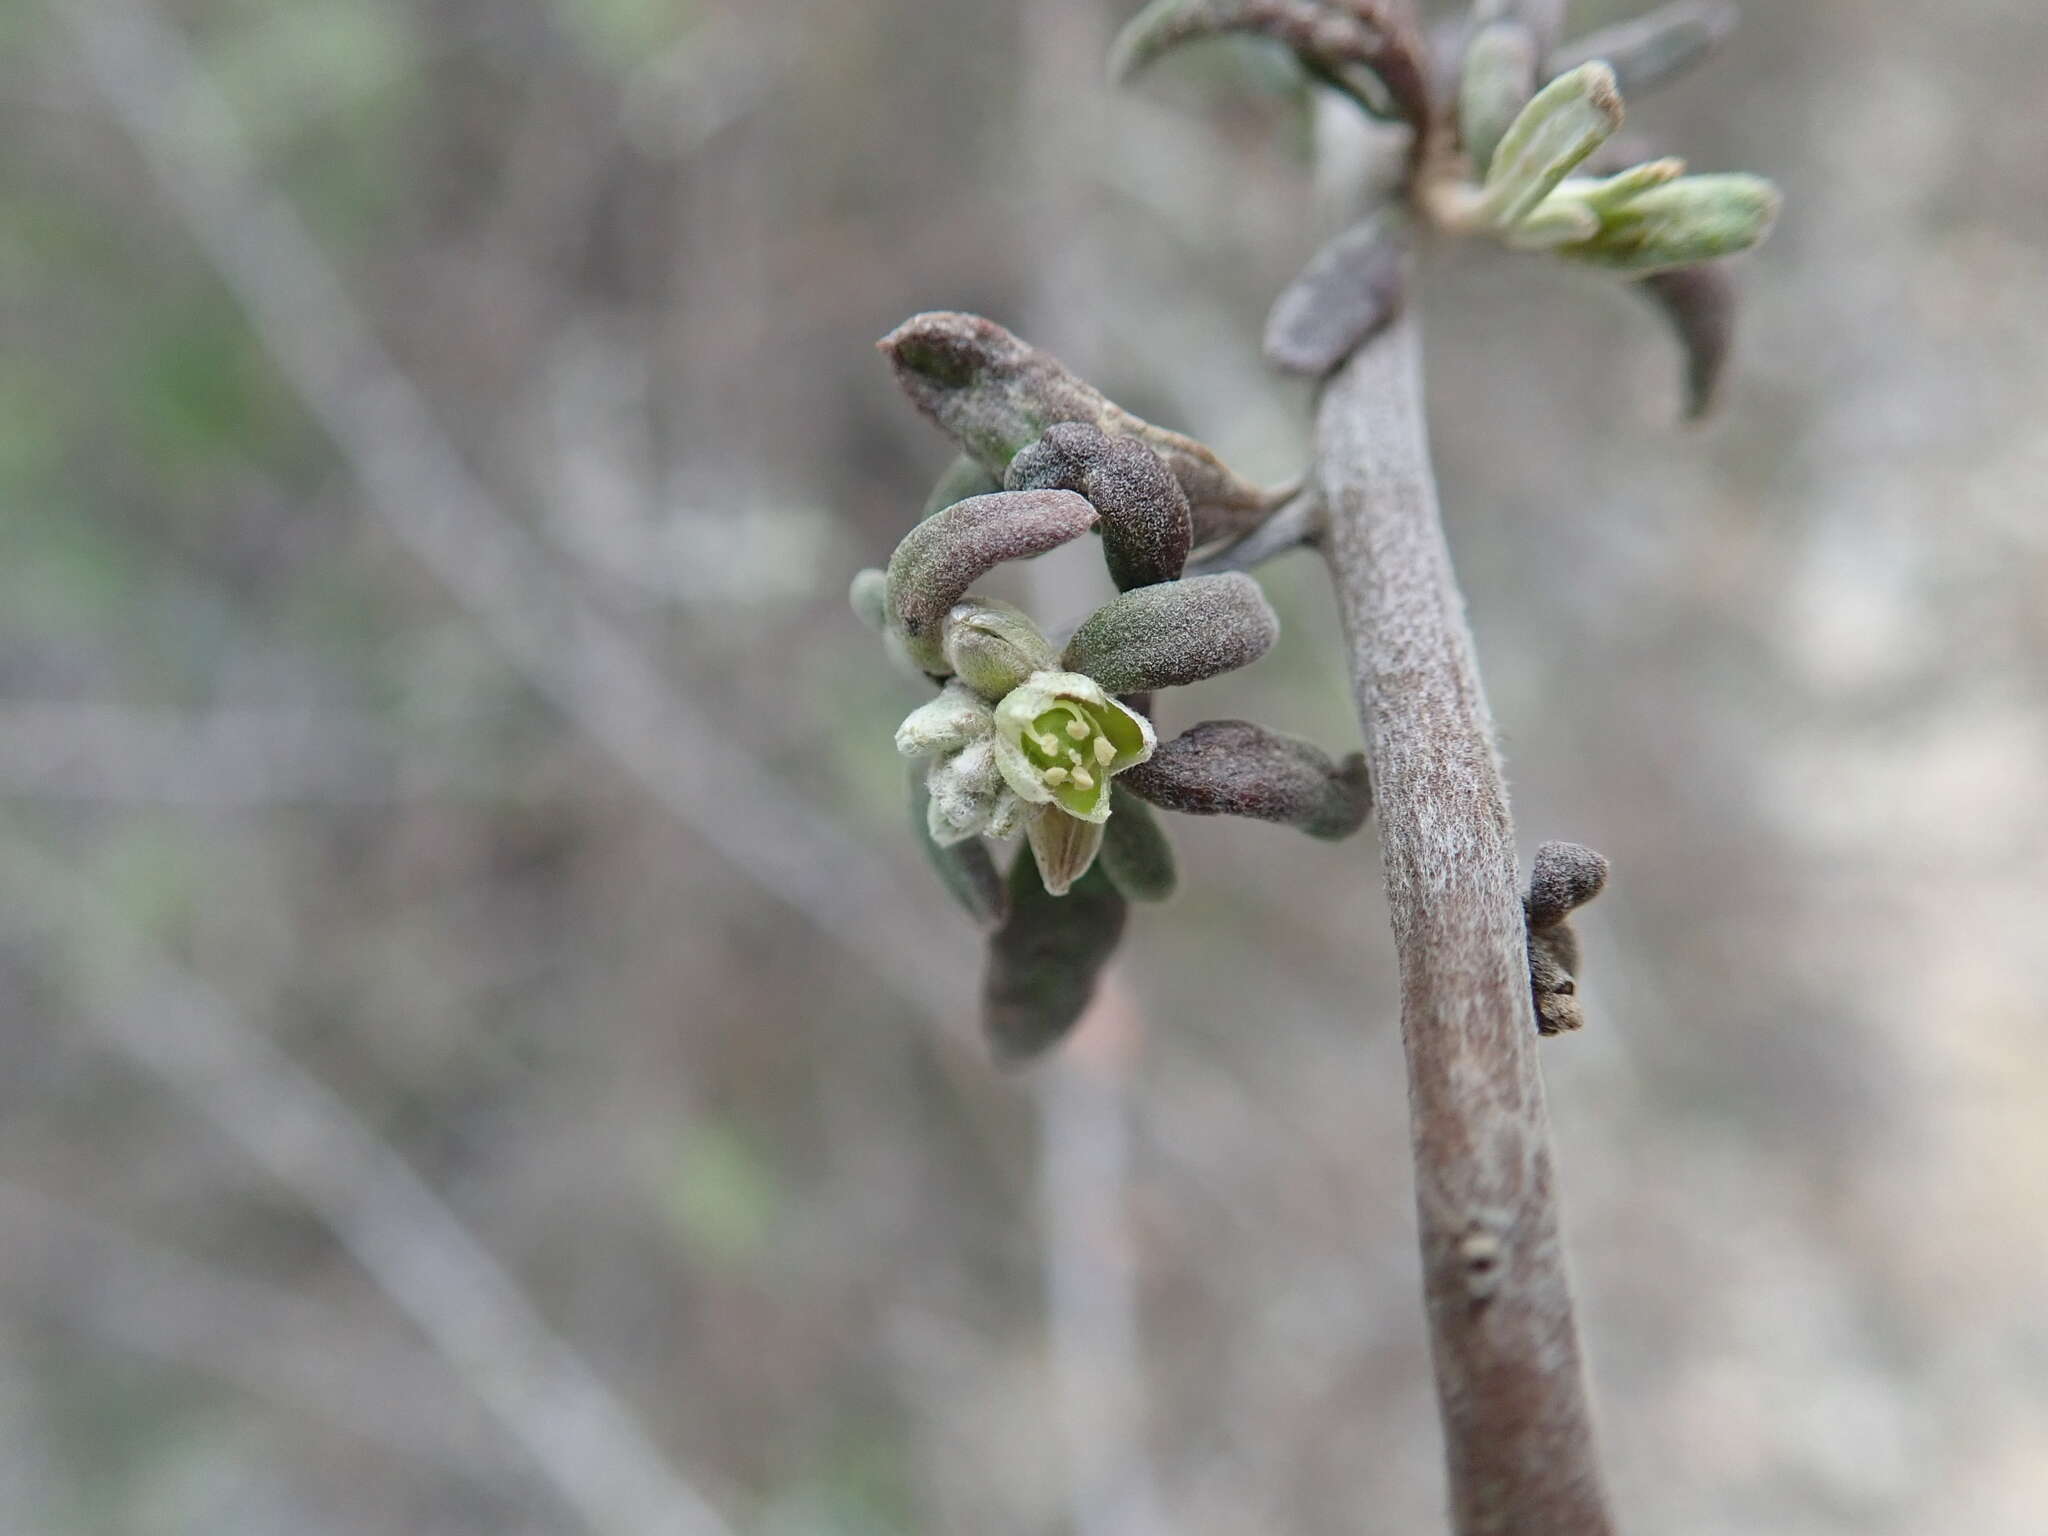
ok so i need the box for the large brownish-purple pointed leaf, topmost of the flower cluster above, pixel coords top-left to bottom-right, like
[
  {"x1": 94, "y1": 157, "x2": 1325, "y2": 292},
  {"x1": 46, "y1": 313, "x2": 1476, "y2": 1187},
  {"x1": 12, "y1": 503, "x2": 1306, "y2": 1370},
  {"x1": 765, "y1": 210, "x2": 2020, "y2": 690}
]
[{"x1": 877, "y1": 311, "x2": 1276, "y2": 545}]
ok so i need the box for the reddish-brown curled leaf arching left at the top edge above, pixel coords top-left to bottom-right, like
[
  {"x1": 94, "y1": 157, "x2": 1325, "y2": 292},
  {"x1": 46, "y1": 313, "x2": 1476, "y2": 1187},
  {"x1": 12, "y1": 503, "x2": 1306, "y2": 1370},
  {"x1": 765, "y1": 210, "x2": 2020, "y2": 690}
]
[{"x1": 1110, "y1": 0, "x2": 1430, "y2": 127}]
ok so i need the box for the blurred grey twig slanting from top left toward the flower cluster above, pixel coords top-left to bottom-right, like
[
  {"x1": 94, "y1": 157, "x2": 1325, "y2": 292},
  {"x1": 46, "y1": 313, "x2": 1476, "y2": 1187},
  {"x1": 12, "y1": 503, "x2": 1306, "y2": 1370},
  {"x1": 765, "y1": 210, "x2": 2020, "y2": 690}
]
[{"x1": 63, "y1": 0, "x2": 961, "y2": 1036}]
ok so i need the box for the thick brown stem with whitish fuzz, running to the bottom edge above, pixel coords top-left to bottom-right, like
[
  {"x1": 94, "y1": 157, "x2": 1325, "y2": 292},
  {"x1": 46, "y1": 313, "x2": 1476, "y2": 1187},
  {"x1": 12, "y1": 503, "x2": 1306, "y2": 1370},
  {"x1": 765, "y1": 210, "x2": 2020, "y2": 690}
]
[{"x1": 1317, "y1": 311, "x2": 1612, "y2": 1536}]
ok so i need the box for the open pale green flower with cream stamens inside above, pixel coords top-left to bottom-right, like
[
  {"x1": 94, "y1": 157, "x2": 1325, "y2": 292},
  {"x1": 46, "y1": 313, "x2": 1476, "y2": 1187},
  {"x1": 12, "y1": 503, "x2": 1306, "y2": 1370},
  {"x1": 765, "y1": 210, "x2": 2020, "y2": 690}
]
[{"x1": 995, "y1": 671, "x2": 1157, "y2": 823}]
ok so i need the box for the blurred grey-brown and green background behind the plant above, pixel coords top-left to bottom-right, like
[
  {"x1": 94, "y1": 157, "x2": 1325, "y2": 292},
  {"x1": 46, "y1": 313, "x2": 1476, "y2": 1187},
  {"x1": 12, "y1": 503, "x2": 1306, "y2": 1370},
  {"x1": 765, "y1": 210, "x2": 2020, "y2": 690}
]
[{"x1": 0, "y1": 0, "x2": 2048, "y2": 1536}]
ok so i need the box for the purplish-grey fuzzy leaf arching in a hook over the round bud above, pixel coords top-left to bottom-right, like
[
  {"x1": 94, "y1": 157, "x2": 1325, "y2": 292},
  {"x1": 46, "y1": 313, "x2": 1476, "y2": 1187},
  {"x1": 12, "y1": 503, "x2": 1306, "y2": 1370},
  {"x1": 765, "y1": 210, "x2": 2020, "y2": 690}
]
[{"x1": 889, "y1": 492, "x2": 1096, "y2": 674}]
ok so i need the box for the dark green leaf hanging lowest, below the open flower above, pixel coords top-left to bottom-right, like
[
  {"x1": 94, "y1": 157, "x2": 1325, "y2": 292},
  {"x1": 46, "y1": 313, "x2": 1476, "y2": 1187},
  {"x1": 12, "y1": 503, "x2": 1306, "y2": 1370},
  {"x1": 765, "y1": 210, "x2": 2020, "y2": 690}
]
[{"x1": 981, "y1": 848, "x2": 1130, "y2": 1065}]
